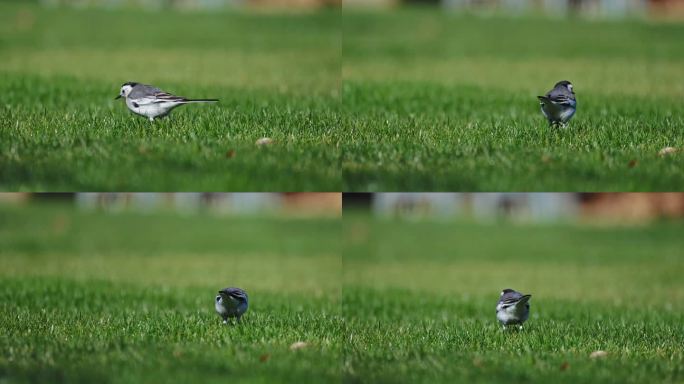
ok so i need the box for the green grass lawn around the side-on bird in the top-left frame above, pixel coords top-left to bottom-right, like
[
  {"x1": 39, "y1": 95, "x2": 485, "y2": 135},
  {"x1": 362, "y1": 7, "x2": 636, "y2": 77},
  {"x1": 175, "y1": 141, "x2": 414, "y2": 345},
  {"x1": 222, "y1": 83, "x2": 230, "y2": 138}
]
[{"x1": 0, "y1": 2, "x2": 342, "y2": 191}]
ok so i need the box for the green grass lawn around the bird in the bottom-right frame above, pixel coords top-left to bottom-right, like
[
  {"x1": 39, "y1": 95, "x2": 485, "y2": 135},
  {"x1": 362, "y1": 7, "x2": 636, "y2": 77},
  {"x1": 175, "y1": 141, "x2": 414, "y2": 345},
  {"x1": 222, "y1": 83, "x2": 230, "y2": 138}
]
[{"x1": 343, "y1": 213, "x2": 684, "y2": 383}]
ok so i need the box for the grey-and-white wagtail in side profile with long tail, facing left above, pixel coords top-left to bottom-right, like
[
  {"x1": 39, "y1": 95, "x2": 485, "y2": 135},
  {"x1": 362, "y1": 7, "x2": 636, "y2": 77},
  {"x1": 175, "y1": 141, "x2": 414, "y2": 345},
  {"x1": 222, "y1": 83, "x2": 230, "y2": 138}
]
[{"x1": 114, "y1": 82, "x2": 218, "y2": 121}]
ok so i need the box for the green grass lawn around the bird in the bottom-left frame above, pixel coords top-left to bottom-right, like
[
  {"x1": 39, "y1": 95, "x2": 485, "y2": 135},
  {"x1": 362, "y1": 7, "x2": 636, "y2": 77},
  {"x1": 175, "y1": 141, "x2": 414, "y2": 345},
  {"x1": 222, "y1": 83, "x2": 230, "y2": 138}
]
[{"x1": 0, "y1": 207, "x2": 343, "y2": 383}]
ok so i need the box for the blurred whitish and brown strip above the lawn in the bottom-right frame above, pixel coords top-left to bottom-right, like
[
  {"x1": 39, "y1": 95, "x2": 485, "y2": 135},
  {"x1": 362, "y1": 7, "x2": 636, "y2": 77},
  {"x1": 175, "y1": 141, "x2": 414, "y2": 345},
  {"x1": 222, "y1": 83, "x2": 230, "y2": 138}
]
[{"x1": 344, "y1": 193, "x2": 684, "y2": 223}]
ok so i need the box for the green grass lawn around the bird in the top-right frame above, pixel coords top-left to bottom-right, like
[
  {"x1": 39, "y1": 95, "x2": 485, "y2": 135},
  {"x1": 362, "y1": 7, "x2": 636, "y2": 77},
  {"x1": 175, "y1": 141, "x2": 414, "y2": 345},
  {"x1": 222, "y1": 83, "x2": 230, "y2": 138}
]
[{"x1": 339, "y1": 9, "x2": 684, "y2": 191}]
